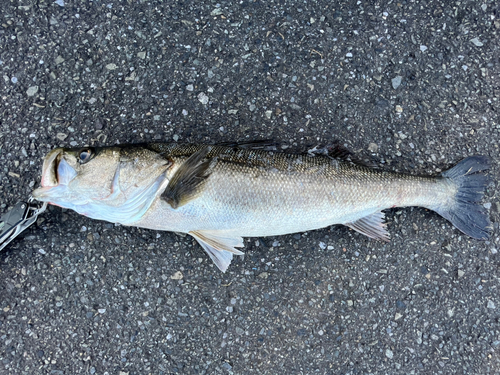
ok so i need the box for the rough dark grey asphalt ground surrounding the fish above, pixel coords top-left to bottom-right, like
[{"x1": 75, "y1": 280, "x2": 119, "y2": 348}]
[{"x1": 0, "y1": 0, "x2": 500, "y2": 375}]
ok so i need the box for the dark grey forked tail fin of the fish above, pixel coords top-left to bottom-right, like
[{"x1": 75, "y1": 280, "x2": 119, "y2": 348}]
[{"x1": 436, "y1": 155, "x2": 490, "y2": 240}]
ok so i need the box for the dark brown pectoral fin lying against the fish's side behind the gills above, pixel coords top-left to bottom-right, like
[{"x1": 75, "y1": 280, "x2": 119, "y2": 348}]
[{"x1": 161, "y1": 147, "x2": 217, "y2": 209}]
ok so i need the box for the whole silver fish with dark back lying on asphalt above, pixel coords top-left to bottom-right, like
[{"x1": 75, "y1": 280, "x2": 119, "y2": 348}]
[{"x1": 33, "y1": 143, "x2": 491, "y2": 272}]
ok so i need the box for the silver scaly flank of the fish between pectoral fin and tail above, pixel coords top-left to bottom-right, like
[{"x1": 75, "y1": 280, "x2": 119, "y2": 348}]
[{"x1": 143, "y1": 158, "x2": 447, "y2": 237}]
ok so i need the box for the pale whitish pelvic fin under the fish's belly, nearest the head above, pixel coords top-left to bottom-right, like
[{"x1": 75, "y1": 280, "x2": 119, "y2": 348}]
[{"x1": 189, "y1": 231, "x2": 244, "y2": 272}]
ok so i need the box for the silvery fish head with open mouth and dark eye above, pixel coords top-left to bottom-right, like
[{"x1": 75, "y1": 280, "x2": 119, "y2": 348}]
[{"x1": 33, "y1": 147, "x2": 169, "y2": 217}]
